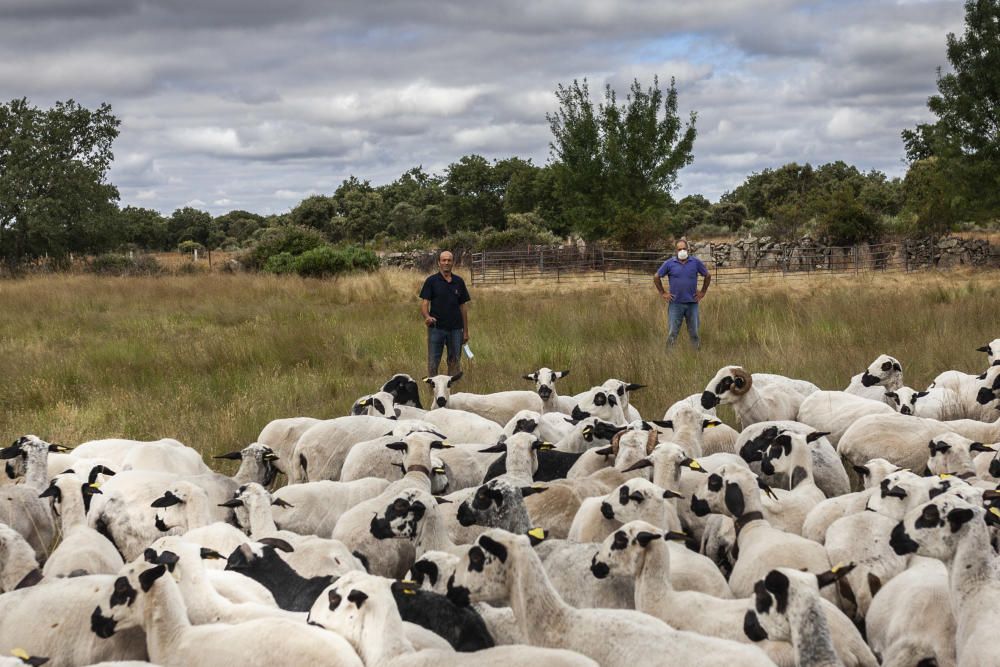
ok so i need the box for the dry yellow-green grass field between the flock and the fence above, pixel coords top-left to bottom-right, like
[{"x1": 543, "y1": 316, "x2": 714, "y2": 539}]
[{"x1": 0, "y1": 271, "x2": 1000, "y2": 462}]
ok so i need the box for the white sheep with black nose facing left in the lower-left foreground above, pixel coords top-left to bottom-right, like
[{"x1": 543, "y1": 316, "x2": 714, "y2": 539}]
[{"x1": 91, "y1": 561, "x2": 363, "y2": 667}]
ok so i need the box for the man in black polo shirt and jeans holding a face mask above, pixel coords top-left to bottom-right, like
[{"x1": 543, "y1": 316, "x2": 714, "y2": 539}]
[{"x1": 420, "y1": 250, "x2": 470, "y2": 377}]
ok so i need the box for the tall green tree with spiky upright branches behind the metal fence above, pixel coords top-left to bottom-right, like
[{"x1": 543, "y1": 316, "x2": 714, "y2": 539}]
[{"x1": 546, "y1": 77, "x2": 696, "y2": 238}]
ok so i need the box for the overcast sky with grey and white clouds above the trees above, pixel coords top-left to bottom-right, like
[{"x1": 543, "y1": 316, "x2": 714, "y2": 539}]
[{"x1": 0, "y1": 0, "x2": 964, "y2": 214}]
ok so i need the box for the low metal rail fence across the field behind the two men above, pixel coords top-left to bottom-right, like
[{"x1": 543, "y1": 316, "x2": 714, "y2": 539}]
[{"x1": 470, "y1": 243, "x2": 919, "y2": 285}]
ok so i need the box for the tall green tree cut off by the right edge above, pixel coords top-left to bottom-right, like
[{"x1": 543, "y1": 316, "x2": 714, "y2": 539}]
[{"x1": 903, "y1": 0, "x2": 1000, "y2": 217}]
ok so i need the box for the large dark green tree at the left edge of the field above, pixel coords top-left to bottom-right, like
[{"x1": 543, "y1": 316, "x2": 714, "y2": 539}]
[{"x1": 0, "y1": 98, "x2": 121, "y2": 267}]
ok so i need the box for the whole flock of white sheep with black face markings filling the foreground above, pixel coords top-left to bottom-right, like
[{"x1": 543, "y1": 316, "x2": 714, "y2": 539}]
[{"x1": 0, "y1": 339, "x2": 1000, "y2": 667}]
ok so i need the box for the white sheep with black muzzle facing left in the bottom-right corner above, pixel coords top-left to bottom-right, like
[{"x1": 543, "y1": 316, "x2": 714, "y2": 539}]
[{"x1": 890, "y1": 493, "x2": 1000, "y2": 665}]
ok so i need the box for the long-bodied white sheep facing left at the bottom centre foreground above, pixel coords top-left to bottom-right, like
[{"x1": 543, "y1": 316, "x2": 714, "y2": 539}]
[{"x1": 448, "y1": 530, "x2": 773, "y2": 667}]
